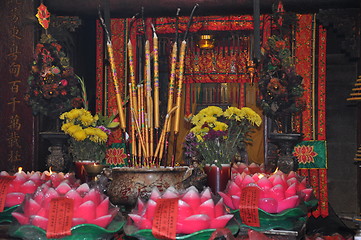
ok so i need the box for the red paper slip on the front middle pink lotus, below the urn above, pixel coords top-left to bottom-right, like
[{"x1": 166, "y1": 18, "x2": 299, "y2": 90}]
[{"x1": 152, "y1": 198, "x2": 178, "y2": 239}]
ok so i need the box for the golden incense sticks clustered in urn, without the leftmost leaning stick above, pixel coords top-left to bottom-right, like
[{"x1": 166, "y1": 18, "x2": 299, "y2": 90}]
[{"x1": 128, "y1": 31, "x2": 186, "y2": 167}]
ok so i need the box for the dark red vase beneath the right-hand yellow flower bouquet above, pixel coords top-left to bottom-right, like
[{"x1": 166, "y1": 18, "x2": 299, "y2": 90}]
[{"x1": 204, "y1": 164, "x2": 231, "y2": 194}]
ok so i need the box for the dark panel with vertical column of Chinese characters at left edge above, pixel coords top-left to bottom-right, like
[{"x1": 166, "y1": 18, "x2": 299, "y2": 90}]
[{"x1": 0, "y1": 0, "x2": 34, "y2": 171}]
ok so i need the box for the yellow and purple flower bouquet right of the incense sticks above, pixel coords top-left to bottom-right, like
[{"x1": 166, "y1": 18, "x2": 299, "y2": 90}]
[{"x1": 184, "y1": 106, "x2": 262, "y2": 166}]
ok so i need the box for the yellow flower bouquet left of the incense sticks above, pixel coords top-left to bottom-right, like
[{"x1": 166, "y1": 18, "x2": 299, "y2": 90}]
[{"x1": 59, "y1": 108, "x2": 119, "y2": 162}]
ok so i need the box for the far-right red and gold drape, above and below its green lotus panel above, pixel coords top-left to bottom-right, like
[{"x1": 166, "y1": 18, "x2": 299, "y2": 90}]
[{"x1": 295, "y1": 14, "x2": 328, "y2": 217}]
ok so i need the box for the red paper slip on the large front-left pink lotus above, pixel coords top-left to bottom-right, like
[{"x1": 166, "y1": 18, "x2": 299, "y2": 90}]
[{"x1": 46, "y1": 197, "x2": 74, "y2": 238}]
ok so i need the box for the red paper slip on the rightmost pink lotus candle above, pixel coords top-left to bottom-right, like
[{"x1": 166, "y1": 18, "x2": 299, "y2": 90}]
[{"x1": 239, "y1": 187, "x2": 260, "y2": 227}]
